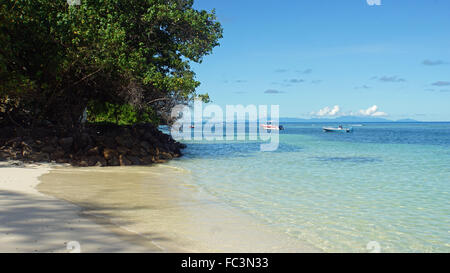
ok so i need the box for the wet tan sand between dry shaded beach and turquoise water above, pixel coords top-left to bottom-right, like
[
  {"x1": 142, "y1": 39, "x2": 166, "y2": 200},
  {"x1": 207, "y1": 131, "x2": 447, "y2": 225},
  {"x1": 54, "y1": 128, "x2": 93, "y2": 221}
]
[{"x1": 37, "y1": 165, "x2": 318, "y2": 252}]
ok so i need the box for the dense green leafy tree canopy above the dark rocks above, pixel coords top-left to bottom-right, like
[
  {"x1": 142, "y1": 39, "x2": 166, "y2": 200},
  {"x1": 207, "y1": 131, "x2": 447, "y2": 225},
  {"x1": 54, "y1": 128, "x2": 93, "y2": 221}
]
[{"x1": 0, "y1": 0, "x2": 222, "y2": 127}]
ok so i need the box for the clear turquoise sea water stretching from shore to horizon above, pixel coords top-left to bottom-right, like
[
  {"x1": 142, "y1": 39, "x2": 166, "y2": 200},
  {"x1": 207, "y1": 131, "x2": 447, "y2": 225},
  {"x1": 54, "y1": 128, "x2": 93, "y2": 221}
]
[{"x1": 165, "y1": 123, "x2": 450, "y2": 252}]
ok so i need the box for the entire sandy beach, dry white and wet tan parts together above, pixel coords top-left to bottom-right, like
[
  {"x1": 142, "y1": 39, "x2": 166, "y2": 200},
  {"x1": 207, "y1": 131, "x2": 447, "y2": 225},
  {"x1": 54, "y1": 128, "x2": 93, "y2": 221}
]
[{"x1": 0, "y1": 160, "x2": 317, "y2": 252}]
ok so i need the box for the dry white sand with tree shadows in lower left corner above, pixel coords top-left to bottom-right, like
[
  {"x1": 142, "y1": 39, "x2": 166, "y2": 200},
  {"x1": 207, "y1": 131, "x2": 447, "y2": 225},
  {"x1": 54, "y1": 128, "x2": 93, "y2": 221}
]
[{"x1": 0, "y1": 162, "x2": 162, "y2": 252}]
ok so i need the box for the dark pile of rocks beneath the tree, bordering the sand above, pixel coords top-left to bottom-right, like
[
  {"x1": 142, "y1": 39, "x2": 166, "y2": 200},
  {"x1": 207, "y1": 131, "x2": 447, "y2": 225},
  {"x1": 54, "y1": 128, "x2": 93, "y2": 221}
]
[{"x1": 0, "y1": 124, "x2": 185, "y2": 167}]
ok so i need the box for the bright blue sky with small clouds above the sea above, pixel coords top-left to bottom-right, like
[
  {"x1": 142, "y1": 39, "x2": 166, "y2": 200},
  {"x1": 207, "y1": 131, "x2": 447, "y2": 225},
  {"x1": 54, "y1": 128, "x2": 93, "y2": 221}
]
[{"x1": 193, "y1": 0, "x2": 450, "y2": 121}]
